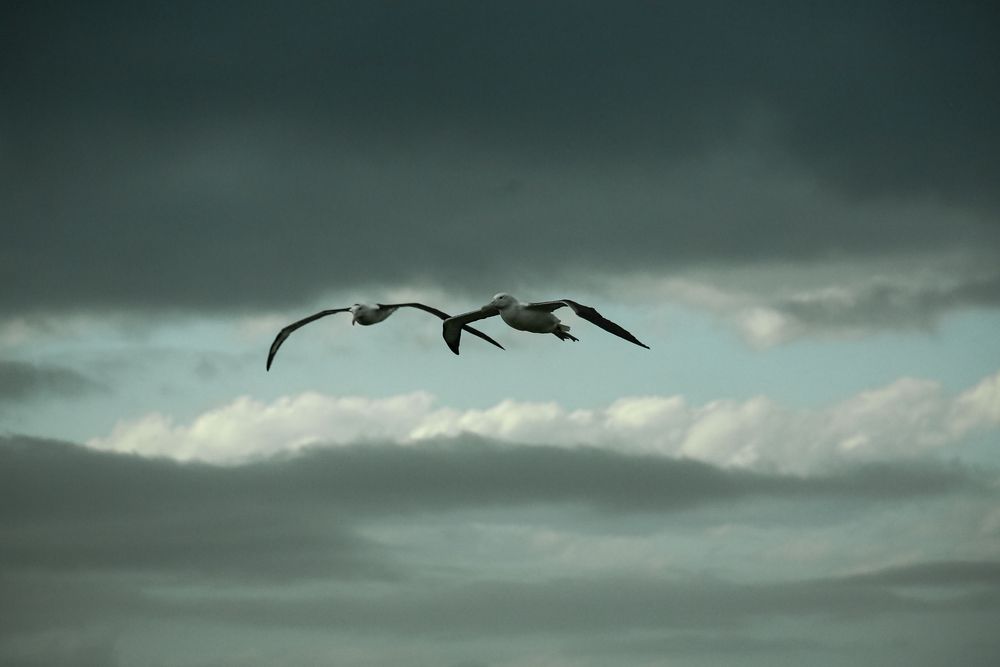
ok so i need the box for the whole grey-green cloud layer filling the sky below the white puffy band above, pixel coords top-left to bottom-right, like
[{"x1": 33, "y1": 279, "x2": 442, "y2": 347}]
[{"x1": 0, "y1": 437, "x2": 1000, "y2": 666}]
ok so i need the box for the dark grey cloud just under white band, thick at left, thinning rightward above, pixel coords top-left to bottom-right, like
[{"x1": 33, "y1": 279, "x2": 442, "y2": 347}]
[{"x1": 0, "y1": 437, "x2": 983, "y2": 580}]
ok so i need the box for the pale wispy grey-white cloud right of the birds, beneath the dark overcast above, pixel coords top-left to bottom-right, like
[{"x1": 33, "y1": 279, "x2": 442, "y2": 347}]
[{"x1": 628, "y1": 268, "x2": 1000, "y2": 348}]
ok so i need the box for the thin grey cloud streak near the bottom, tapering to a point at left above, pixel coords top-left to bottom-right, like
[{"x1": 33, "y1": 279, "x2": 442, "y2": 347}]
[{"x1": 176, "y1": 562, "x2": 1000, "y2": 635}]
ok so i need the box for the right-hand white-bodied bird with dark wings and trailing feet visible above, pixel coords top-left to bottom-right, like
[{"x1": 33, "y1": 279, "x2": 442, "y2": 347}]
[{"x1": 441, "y1": 292, "x2": 649, "y2": 354}]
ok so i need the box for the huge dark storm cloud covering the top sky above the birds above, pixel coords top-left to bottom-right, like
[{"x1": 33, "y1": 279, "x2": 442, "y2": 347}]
[{"x1": 0, "y1": 3, "x2": 1000, "y2": 311}]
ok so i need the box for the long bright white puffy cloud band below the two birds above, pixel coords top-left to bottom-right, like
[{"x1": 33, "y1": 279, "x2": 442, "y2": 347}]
[{"x1": 88, "y1": 373, "x2": 1000, "y2": 472}]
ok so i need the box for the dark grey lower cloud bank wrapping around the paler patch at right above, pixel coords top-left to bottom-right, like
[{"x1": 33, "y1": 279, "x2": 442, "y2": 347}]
[{"x1": 0, "y1": 436, "x2": 1000, "y2": 665}]
